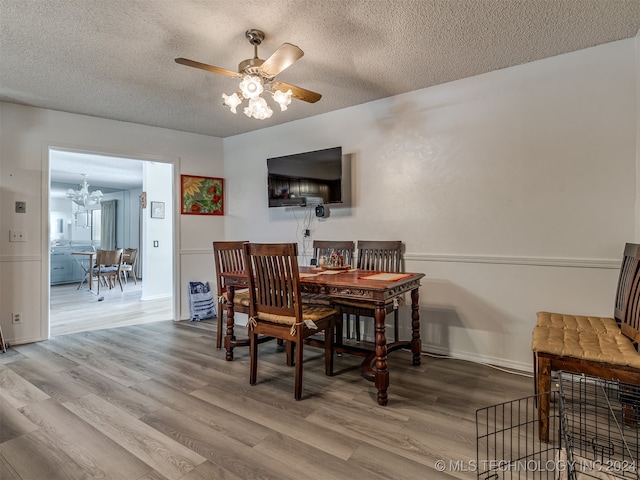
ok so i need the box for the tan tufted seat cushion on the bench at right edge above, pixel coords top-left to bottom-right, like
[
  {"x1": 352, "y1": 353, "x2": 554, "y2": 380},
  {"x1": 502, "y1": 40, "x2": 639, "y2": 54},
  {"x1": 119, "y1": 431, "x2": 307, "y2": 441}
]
[{"x1": 531, "y1": 326, "x2": 640, "y2": 368}]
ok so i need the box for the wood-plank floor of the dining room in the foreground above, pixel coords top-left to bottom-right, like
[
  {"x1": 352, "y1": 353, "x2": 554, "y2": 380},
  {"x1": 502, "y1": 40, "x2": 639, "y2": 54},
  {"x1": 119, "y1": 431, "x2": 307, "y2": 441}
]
[{"x1": 0, "y1": 321, "x2": 533, "y2": 480}]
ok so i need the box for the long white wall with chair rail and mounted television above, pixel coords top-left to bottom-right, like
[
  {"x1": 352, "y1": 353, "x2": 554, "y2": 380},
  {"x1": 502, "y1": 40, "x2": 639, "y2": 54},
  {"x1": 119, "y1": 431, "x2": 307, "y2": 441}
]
[{"x1": 224, "y1": 40, "x2": 639, "y2": 369}]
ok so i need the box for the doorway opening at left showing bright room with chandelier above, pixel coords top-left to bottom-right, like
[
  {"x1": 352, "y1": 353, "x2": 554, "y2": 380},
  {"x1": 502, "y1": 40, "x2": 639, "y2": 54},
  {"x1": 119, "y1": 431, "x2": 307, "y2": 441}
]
[{"x1": 48, "y1": 148, "x2": 174, "y2": 336}]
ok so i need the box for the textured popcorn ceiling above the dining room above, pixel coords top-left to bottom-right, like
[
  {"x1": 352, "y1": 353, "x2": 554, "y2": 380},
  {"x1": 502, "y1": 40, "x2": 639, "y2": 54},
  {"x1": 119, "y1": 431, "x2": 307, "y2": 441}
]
[{"x1": 0, "y1": 0, "x2": 640, "y2": 137}]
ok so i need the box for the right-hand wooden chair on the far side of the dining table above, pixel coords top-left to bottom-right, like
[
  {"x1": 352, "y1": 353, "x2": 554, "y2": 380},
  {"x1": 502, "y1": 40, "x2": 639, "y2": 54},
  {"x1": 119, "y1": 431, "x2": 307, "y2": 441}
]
[{"x1": 335, "y1": 240, "x2": 404, "y2": 342}]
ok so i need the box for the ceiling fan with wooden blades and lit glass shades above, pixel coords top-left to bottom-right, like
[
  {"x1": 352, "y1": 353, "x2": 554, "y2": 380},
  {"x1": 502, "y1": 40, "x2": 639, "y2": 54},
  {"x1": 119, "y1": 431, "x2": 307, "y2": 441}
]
[{"x1": 175, "y1": 29, "x2": 322, "y2": 119}]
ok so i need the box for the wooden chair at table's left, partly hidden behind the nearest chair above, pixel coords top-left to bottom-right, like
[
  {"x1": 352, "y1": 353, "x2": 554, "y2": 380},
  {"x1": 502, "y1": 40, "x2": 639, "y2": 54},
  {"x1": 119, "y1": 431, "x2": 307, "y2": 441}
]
[{"x1": 213, "y1": 241, "x2": 249, "y2": 348}]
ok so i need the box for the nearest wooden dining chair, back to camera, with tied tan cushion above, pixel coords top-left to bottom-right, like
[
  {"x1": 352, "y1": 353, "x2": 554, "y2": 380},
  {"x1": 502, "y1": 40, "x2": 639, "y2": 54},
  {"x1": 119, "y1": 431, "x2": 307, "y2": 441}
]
[{"x1": 244, "y1": 243, "x2": 338, "y2": 400}]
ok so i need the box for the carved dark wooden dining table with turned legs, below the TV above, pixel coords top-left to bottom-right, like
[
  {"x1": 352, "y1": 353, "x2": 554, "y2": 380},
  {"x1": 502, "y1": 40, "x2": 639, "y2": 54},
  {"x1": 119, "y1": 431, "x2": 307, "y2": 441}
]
[{"x1": 222, "y1": 266, "x2": 424, "y2": 405}]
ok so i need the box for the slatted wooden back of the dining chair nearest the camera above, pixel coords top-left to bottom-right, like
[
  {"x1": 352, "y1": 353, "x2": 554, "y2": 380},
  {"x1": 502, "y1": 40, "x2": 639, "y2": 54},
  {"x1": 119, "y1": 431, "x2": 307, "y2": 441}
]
[{"x1": 244, "y1": 243, "x2": 302, "y2": 318}]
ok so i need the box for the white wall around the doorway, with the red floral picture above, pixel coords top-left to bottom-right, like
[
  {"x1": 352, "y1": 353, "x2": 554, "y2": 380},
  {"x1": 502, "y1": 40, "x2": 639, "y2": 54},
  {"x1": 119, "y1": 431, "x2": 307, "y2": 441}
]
[{"x1": 0, "y1": 102, "x2": 225, "y2": 344}]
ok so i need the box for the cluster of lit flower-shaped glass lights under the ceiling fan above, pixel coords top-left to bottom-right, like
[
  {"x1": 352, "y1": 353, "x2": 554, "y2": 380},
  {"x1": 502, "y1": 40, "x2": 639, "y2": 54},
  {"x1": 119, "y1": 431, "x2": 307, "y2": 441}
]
[{"x1": 222, "y1": 75, "x2": 291, "y2": 120}]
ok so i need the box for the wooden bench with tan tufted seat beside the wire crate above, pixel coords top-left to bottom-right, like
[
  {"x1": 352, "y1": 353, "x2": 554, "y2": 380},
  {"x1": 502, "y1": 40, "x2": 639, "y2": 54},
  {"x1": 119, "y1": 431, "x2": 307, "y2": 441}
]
[{"x1": 531, "y1": 243, "x2": 640, "y2": 442}]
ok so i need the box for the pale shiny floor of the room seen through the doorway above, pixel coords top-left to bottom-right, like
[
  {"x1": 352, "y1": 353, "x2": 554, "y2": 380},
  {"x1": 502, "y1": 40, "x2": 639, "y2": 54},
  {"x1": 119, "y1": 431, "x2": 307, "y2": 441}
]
[{"x1": 49, "y1": 279, "x2": 173, "y2": 336}]
